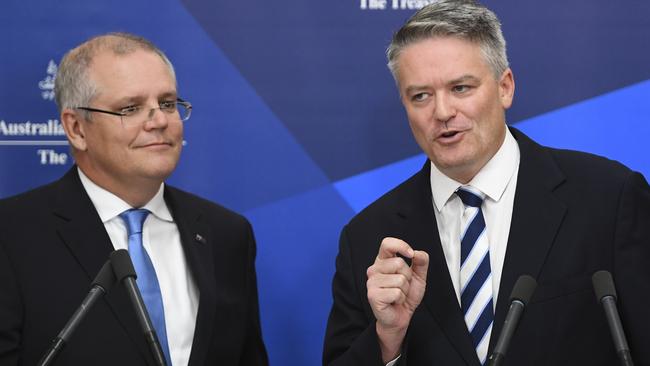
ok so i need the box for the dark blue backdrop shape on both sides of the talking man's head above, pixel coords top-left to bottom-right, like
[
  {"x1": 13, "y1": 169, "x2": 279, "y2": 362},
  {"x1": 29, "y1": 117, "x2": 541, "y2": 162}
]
[{"x1": 184, "y1": 0, "x2": 650, "y2": 180}]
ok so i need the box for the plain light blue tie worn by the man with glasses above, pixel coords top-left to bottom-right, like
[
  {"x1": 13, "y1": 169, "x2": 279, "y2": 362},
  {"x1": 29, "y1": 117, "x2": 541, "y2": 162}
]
[{"x1": 120, "y1": 209, "x2": 172, "y2": 366}]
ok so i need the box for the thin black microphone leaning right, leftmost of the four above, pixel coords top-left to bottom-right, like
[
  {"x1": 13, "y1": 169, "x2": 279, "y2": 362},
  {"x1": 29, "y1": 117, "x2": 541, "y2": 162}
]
[{"x1": 37, "y1": 260, "x2": 116, "y2": 366}]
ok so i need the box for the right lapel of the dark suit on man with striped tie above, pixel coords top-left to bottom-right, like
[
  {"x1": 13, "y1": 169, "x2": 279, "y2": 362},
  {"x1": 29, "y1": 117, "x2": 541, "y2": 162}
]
[{"x1": 490, "y1": 128, "x2": 566, "y2": 351}]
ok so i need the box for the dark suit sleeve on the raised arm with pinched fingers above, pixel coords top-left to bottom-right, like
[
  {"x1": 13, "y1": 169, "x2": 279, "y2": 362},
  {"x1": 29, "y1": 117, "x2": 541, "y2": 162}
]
[{"x1": 323, "y1": 227, "x2": 383, "y2": 366}]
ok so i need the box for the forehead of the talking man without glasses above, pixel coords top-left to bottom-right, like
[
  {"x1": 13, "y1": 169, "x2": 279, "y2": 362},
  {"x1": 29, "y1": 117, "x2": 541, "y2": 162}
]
[{"x1": 397, "y1": 37, "x2": 489, "y2": 84}]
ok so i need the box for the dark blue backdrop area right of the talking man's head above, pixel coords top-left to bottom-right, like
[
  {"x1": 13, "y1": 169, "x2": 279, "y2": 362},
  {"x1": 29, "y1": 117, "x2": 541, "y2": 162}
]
[{"x1": 485, "y1": 0, "x2": 650, "y2": 123}]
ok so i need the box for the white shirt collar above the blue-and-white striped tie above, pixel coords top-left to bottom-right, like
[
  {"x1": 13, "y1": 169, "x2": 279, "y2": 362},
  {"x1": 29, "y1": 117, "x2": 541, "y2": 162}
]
[{"x1": 431, "y1": 128, "x2": 519, "y2": 212}]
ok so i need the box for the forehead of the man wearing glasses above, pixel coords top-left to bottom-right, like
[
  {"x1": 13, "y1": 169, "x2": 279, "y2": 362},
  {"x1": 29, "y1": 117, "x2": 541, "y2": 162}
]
[{"x1": 89, "y1": 50, "x2": 176, "y2": 98}]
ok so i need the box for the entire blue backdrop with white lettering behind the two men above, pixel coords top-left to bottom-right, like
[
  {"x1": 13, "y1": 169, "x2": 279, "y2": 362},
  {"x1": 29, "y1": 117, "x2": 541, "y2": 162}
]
[{"x1": 0, "y1": 0, "x2": 650, "y2": 366}]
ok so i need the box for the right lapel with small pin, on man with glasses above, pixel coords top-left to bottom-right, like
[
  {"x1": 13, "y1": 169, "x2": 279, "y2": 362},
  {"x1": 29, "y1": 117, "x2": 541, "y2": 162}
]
[{"x1": 165, "y1": 186, "x2": 216, "y2": 366}]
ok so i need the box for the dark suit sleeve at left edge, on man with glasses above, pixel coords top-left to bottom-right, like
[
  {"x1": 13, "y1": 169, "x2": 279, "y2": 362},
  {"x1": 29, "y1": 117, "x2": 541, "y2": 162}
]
[{"x1": 0, "y1": 233, "x2": 23, "y2": 366}]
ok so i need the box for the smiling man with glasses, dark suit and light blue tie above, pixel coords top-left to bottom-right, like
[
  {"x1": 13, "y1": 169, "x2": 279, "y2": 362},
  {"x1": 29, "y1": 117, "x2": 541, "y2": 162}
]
[{"x1": 0, "y1": 33, "x2": 268, "y2": 366}]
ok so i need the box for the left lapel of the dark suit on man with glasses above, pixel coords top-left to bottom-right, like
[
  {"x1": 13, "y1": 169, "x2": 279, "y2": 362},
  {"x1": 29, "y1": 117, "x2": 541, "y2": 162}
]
[{"x1": 53, "y1": 166, "x2": 153, "y2": 364}]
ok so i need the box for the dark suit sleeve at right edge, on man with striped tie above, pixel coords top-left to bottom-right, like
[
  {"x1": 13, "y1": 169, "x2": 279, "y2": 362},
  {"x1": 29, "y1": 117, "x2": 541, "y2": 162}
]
[{"x1": 613, "y1": 173, "x2": 650, "y2": 365}]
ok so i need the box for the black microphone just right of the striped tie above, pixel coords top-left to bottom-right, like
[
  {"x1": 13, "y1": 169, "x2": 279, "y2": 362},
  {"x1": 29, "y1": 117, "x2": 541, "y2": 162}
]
[{"x1": 488, "y1": 275, "x2": 537, "y2": 366}]
